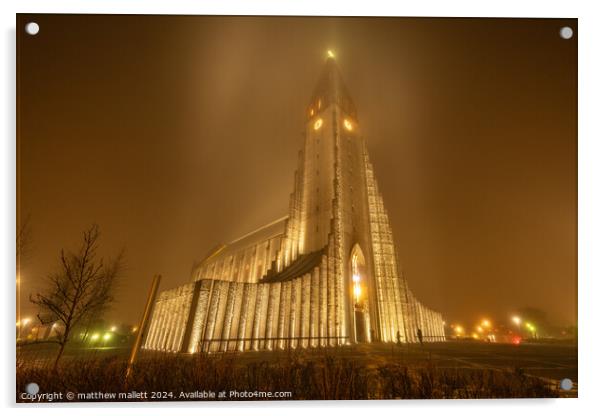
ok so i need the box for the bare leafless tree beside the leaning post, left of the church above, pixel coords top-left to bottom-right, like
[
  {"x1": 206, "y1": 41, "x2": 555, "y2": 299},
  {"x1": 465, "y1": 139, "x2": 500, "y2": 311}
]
[{"x1": 30, "y1": 225, "x2": 123, "y2": 370}]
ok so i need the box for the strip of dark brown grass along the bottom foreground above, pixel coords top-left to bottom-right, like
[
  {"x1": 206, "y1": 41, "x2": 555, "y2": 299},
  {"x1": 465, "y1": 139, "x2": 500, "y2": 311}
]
[{"x1": 17, "y1": 350, "x2": 558, "y2": 401}]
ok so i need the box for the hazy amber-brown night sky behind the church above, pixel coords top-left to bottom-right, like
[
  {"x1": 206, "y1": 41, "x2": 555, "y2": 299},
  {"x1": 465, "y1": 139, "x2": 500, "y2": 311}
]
[{"x1": 17, "y1": 15, "x2": 577, "y2": 324}]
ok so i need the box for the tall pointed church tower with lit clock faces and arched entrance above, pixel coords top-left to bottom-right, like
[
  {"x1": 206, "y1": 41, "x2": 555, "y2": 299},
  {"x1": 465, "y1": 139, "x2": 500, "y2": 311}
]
[{"x1": 268, "y1": 51, "x2": 436, "y2": 342}]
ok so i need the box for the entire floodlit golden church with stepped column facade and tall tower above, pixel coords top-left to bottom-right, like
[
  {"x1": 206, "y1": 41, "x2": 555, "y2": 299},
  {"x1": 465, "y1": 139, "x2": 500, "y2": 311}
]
[{"x1": 144, "y1": 52, "x2": 445, "y2": 352}]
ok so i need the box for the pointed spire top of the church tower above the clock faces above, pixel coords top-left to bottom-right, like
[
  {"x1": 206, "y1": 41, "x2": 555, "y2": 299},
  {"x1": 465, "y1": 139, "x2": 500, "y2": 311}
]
[{"x1": 308, "y1": 50, "x2": 357, "y2": 118}]
